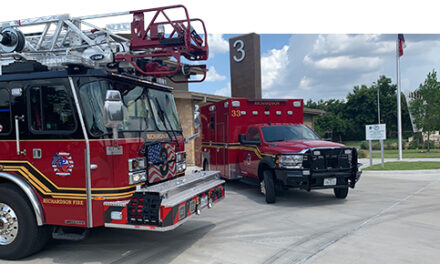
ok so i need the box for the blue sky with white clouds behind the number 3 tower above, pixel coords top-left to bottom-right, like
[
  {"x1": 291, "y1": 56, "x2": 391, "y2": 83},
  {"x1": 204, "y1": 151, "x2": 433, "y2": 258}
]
[{"x1": 190, "y1": 34, "x2": 440, "y2": 100}]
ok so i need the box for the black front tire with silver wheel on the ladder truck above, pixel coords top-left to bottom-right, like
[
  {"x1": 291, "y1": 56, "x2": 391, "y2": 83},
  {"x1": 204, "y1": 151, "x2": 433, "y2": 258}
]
[{"x1": 0, "y1": 183, "x2": 51, "y2": 260}]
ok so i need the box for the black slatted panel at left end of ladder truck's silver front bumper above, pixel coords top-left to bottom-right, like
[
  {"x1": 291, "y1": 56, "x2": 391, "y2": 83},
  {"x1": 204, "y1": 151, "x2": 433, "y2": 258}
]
[{"x1": 127, "y1": 193, "x2": 160, "y2": 225}]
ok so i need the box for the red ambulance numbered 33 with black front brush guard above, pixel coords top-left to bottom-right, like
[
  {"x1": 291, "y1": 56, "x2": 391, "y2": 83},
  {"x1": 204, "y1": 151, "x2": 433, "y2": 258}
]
[{"x1": 198, "y1": 98, "x2": 361, "y2": 203}]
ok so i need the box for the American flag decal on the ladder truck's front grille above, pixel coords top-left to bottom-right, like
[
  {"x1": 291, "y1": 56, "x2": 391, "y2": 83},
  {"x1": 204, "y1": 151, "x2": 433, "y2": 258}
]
[{"x1": 147, "y1": 143, "x2": 176, "y2": 183}]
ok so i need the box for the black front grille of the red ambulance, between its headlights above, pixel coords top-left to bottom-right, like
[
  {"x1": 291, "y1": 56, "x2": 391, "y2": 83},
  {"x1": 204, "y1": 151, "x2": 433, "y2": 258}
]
[{"x1": 309, "y1": 148, "x2": 352, "y2": 171}]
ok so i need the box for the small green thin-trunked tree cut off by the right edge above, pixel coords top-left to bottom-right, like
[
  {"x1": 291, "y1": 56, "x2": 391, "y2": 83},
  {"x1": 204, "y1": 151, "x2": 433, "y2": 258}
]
[{"x1": 410, "y1": 70, "x2": 440, "y2": 152}]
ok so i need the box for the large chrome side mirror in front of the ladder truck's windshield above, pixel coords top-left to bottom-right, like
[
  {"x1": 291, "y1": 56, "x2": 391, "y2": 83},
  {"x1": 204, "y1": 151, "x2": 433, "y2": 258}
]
[{"x1": 104, "y1": 90, "x2": 124, "y2": 139}]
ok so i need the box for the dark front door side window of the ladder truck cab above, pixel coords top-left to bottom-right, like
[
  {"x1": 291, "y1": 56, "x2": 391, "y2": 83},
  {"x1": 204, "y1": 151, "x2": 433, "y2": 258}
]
[{"x1": 29, "y1": 85, "x2": 76, "y2": 133}]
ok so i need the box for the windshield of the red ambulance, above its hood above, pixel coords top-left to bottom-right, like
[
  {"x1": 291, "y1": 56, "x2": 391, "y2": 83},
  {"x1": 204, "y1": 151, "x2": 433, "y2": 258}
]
[{"x1": 261, "y1": 125, "x2": 319, "y2": 142}]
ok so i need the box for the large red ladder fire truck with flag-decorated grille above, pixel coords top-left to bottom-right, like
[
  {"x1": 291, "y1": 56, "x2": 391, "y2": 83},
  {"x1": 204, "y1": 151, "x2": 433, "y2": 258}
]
[{"x1": 0, "y1": 5, "x2": 225, "y2": 259}]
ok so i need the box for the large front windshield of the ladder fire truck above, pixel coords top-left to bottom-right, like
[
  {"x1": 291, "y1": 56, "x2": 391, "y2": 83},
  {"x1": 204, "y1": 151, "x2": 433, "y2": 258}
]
[{"x1": 80, "y1": 80, "x2": 181, "y2": 136}]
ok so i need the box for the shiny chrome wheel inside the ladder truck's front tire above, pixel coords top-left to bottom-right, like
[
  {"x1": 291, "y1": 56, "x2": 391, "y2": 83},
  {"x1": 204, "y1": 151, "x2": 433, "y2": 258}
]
[{"x1": 0, "y1": 203, "x2": 18, "y2": 246}]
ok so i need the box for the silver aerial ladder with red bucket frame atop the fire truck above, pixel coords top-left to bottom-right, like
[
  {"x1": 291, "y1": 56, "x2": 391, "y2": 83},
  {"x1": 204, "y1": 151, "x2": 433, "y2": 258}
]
[{"x1": 0, "y1": 5, "x2": 209, "y2": 82}]
